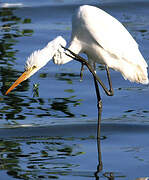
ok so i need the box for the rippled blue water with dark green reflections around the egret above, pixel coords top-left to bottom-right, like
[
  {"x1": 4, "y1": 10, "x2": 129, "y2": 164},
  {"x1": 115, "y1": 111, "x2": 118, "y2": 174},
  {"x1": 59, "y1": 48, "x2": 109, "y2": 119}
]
[{"x1": 0, "y1": 0, "x2": 149, "y2": 180}]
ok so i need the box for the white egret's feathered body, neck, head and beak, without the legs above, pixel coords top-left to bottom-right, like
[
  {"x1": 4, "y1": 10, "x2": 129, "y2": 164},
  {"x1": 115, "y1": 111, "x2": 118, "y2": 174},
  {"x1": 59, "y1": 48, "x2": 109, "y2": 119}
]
[{"x1": 6, "y1": 5, "x2": 149, "y2": 94}]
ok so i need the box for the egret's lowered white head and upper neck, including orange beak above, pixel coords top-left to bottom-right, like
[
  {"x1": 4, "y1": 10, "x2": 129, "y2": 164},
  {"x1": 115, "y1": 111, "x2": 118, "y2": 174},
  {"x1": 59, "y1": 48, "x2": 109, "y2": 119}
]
[{"x1": 5, "y1": 36, "x2": 66, "y2": 95}]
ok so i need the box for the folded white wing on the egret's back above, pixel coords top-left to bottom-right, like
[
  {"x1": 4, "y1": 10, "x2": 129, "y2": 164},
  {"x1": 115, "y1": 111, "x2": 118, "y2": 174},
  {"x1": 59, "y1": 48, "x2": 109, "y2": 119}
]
[{"x1": 82, "y1": 8, "x2": 147, "y2": 66}]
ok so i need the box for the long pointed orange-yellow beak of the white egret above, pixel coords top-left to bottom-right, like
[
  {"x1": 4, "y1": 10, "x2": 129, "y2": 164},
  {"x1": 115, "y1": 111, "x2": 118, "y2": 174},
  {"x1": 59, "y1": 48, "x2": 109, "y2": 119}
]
[{"x1": 5, "y1": 70, "x2": 32, "y2": 95}]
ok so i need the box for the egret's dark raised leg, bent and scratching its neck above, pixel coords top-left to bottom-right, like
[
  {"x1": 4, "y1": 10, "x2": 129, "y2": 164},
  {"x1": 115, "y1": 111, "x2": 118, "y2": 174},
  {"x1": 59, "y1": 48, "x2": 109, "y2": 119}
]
[{"x1": 62, "y1": 46, "x2": 114, "y2": 96}]
